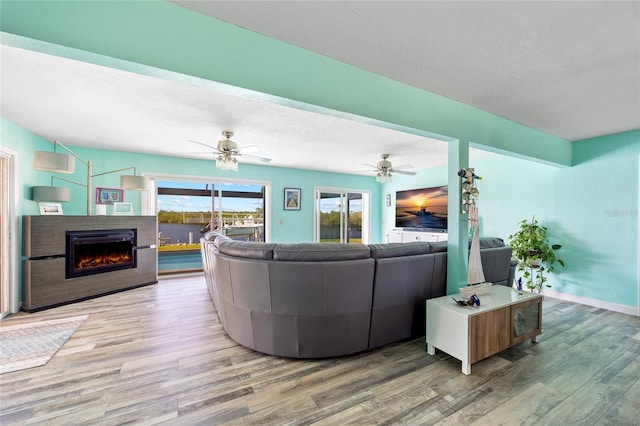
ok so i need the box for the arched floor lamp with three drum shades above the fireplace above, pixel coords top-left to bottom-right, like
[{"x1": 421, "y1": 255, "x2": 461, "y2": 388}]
[{"x1": 32, "y1": 140, "x2": 149, "y2": 216}]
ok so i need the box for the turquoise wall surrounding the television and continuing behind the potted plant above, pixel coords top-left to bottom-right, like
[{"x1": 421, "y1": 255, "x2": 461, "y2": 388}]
[{"x1": 382, "y1": 131, "x2": 640, "y2": 311}]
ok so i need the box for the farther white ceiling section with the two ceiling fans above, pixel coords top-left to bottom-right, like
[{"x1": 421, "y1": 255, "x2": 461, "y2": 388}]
[{"x1": 0, "y1": 45, "x2": 464, "y2": 174}]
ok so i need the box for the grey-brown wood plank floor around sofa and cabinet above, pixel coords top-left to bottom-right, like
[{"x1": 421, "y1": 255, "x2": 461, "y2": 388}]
[{"x1": 0, "y1": 276, "x2": 640, "y2": 425}]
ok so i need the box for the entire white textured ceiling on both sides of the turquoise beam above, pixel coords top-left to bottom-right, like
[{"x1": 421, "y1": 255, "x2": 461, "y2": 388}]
[{"x1": 0, "y1": 1, "x2": 640, "y2": 173}]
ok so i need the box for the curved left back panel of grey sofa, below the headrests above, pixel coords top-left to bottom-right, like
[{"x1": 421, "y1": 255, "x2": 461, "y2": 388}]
[{"x1": 215, "y1": 247, "x2": 375, "y2": 358}]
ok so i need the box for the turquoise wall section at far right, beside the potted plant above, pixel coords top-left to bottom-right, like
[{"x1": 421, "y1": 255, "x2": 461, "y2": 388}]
[{"x1": 554, "y1": 131, "x2": 640, "y2": 306}]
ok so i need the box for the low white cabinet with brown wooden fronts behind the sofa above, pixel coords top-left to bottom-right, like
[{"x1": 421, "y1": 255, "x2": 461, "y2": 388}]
[{"x1": 426, "y1": 285, "x2": 543, "y2": 374}]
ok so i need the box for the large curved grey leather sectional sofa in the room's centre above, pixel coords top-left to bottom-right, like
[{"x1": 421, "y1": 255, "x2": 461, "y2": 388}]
[{"x1": 201, "y1": 232, "x2": 514, "y2": 358}]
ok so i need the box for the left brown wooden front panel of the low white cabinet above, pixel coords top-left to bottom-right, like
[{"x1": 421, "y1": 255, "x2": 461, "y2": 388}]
[{"x1": 469, "y1": 306, "x2": 511, "y2": 364}]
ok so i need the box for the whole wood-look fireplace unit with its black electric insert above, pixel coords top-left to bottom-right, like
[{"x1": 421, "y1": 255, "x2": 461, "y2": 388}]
[{"x1": 23, "y1": 218, "x2": 158, "y2": 312}]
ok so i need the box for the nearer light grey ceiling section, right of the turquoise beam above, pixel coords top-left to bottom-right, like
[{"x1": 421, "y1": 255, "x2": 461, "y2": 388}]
[{"x1": 173, "y1": 0, "x2": 640, "y2": 140}]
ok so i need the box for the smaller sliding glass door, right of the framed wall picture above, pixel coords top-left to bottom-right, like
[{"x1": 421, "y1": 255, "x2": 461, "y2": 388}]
[{"x1": 315, "y1": 188, "x2": 369, "y2": 244}]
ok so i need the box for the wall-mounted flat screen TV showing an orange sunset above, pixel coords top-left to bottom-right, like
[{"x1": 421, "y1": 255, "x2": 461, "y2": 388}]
[{"x1": 396, "y1": 185, "x2": 449, "y2": 232}]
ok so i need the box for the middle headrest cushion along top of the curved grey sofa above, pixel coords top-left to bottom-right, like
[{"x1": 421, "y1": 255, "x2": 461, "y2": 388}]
[{"x1": 273, "y1": 243, "x2": 371, "y2": 262}]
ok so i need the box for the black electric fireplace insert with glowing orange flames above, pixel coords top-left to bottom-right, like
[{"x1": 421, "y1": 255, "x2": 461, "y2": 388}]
[{"x1": 65, "y1": 229, "x2": 137, "y2": 278}]
